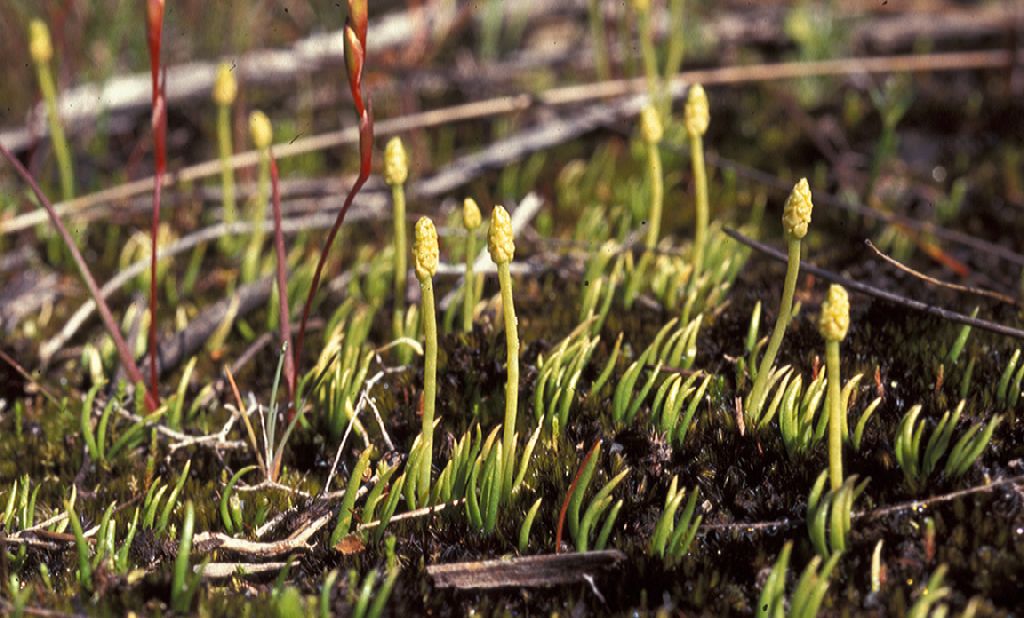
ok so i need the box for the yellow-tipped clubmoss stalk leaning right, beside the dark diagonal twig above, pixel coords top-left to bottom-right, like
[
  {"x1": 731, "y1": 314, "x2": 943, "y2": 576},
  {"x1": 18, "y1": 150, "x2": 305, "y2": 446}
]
[{"x1": 743, "y1": 178, "x2": 814, "y2": 427}]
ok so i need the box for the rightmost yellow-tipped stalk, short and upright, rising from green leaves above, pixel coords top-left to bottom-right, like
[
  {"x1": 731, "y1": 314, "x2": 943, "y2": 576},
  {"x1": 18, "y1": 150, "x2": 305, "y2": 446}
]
[{"x1": 818, "y1": 284, "x2": 850, "y2": 491}]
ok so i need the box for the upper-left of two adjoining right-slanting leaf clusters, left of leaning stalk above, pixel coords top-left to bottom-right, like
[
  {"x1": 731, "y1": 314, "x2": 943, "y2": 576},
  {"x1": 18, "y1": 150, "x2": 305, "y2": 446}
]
[{"x1": 611, "y1": 315, "x2": 702, "y2": 427}]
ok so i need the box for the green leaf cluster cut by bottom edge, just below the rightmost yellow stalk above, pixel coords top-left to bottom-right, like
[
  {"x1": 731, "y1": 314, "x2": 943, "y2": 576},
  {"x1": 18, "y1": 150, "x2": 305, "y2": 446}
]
[{"x1": 758, "y1": 541, "x2": 840, "y2": 618}]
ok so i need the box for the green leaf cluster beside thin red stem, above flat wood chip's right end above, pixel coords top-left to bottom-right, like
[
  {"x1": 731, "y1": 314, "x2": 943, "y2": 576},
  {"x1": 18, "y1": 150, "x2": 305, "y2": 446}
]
[{"x1": 565, "y1": 442, "x2": 630, "y2": 551}]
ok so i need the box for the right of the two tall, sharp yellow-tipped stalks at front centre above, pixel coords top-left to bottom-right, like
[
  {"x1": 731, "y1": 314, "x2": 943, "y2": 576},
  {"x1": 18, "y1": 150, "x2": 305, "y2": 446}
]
[{"x1": 487, "y1": 206, "x2": 519, "y2": 490}]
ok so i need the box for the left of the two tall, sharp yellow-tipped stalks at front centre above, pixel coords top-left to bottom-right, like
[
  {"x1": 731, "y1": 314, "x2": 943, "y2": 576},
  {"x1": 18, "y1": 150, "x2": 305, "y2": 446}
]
[{"x1": 413, "y1": 217, "x2": 438, "y2": 503}]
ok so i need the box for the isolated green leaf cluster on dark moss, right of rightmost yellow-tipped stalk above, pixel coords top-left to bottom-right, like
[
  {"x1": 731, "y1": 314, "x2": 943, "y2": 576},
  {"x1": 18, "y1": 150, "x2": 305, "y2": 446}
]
[{"x1": 895, "y1": 401, "x2": 1002, "y2": 493}]
